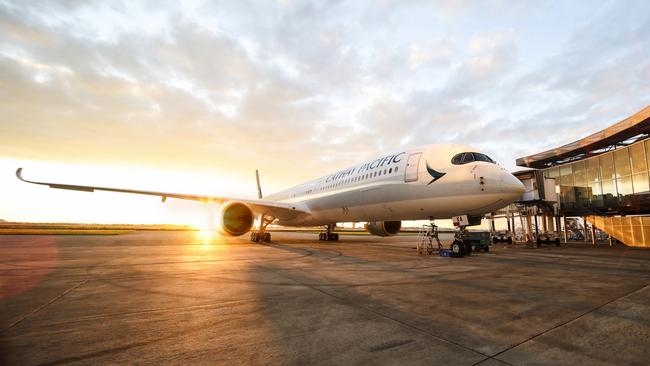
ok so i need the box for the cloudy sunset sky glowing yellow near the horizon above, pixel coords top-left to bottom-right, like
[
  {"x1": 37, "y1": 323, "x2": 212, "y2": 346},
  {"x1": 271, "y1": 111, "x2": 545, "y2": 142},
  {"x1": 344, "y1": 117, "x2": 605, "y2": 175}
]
[{"x1": 0, "y1": 0, "x2": 650, "y2": 223}]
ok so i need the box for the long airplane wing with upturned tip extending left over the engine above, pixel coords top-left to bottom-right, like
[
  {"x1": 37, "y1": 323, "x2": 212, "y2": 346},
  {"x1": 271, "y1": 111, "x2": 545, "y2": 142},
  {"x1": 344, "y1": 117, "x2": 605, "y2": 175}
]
[{"x1": 16, "y1": 168, "x2": 309, "y2": 220}]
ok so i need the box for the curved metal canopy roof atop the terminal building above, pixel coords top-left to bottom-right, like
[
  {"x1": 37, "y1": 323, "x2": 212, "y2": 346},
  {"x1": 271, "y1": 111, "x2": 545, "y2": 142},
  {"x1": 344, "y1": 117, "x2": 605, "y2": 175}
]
[{"x1": 517, "y1": 105, "x2": 650, "y2": 169}]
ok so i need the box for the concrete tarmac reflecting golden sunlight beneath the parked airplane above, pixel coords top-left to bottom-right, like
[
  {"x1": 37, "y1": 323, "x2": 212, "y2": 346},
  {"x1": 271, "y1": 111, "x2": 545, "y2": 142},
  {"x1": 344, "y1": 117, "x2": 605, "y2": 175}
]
[{"x1": 0, "y1": 232, "x2": 650, "y2": 365}]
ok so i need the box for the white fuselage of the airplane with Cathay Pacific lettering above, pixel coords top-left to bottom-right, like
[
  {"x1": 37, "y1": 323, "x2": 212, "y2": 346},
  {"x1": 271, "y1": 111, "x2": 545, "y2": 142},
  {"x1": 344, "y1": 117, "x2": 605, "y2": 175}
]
[{"x1": 264, "y1": 144, "x2": 524, "y2": 226}]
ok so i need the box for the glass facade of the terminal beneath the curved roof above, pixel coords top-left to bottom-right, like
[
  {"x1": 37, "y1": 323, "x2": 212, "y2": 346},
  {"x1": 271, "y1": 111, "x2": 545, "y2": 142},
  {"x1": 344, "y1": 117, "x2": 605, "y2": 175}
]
[{"x1": 544, "y1": 139, "x2": 650, "y2": 212}]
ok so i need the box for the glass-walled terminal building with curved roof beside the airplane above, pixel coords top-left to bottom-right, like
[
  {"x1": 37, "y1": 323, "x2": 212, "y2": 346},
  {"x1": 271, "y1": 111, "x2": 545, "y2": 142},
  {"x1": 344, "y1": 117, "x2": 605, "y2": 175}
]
[{"x1": 513, "y1": 106, "x2": 650, "y2": 247}]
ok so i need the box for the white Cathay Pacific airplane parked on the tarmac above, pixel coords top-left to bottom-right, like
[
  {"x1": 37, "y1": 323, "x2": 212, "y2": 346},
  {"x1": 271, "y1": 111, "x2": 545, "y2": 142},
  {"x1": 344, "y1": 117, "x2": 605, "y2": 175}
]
[{"x1": 16, "y1": 144, "x2": 525, "y2": 254}]
